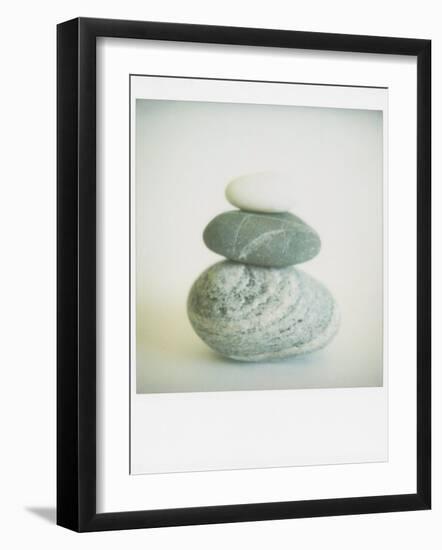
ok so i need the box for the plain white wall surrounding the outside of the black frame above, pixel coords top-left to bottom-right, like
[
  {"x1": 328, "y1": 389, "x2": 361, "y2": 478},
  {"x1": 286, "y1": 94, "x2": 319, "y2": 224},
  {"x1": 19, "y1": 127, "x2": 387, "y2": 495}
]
[{"x1": 0, "y1": 0, "x2": 442, "y2": 549}]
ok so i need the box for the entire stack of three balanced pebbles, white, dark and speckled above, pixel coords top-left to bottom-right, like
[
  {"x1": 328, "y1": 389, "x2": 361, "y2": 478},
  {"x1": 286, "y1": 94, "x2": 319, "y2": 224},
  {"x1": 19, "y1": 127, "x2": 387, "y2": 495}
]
[{"x1": 187, "y1": 173, "x2": 339, "y2": 361}]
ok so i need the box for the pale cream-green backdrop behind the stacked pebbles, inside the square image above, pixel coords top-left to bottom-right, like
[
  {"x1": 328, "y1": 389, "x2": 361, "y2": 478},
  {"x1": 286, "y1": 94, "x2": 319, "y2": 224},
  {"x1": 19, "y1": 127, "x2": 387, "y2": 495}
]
[{"x1": 135, "y1": 97, "x2": 387, "y2": 393}]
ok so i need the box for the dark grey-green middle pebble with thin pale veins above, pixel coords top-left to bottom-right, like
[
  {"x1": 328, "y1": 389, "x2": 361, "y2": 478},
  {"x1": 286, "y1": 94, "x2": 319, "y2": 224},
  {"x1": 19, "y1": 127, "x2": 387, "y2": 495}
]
[{"x1": 203, "y1": 210, "x2": 321, "y2": 267}]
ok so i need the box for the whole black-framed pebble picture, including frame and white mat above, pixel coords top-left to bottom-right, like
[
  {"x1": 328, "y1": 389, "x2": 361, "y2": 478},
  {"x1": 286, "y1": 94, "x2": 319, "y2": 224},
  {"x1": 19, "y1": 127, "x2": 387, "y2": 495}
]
[{"x1": 57, "y1": 18, "x2": 431, "y2": 531}]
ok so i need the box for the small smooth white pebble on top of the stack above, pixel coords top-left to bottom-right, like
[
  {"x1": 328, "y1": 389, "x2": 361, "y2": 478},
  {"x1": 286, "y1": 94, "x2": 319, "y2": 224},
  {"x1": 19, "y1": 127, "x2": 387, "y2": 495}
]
[{"x1": 226, "y1": 172, "x2": 295, "y2": 213}]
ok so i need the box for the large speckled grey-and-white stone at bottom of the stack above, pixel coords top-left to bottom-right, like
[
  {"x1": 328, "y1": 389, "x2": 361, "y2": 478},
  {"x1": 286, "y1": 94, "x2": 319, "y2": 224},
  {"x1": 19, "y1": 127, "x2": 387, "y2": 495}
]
[{"x1": 187, "y1": 261, "x2": 339, "y2": 361}]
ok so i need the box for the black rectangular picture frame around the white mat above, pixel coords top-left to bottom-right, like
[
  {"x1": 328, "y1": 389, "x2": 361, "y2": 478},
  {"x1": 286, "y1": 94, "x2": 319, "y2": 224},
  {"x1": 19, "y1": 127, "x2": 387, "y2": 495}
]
[{"x1": 57, "y1": 18, "x2": 431, "y2": 532}]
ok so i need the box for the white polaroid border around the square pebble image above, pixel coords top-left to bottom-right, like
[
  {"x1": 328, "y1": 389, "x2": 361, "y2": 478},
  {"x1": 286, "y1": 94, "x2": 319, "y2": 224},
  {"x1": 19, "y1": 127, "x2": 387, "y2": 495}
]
[{"x1": 130, "y1": 75, "x2": 388, "y2": 474}]
